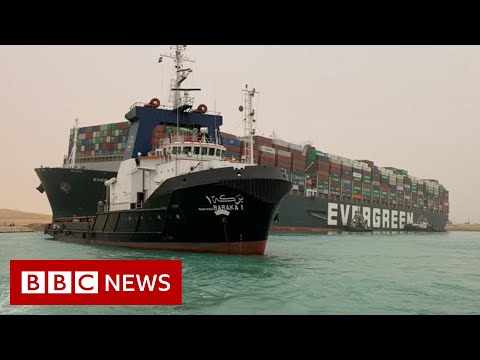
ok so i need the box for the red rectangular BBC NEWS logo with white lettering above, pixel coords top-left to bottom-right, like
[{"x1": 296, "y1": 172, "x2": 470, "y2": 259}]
[{"x1": 10, "y1": 260, "x2": 182, "y2": 305}]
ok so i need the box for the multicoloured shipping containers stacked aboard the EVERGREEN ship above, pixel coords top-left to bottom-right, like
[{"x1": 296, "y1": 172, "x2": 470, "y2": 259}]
[{"x1": 69, "y1": 122, "x2": 449, "y2": 213}]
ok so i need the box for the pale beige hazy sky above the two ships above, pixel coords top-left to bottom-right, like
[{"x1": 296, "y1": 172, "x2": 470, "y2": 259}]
[{"x1": 0, "y1": 45, "x2": 480, "y2": 222}]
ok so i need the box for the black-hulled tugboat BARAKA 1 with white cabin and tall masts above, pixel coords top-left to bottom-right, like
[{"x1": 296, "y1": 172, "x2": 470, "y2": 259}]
[{"x1": 45, "y1": 45, "x2": 292, "y2": 255}]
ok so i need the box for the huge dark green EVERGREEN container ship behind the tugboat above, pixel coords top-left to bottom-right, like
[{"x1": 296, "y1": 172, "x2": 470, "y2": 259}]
[{"x1": 35, "y1": 49, "x2": 449, "y2": 232}]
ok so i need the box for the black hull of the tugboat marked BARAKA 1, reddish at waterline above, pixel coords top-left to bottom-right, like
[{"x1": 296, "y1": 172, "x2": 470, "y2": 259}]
[{"x1": 46, "y1": 166, "x2": 292, "y2": 255}]
